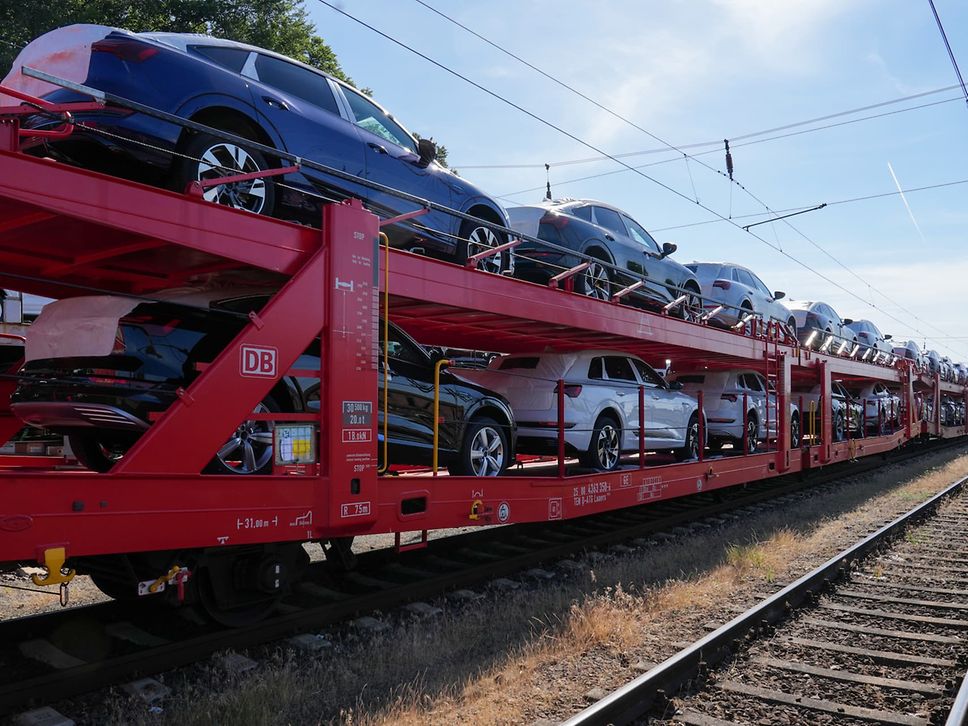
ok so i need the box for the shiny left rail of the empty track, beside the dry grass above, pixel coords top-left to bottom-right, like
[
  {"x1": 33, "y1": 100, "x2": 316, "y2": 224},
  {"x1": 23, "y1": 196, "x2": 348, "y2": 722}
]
[{"x1": 564, "y1": 466, "x2": 968, "y2": 726}]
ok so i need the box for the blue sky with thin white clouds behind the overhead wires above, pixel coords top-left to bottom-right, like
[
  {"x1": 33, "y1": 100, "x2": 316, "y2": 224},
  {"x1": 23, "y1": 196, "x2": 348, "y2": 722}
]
[{"x1": 306, "y1": 0, "x2": 968, "y2": 360}]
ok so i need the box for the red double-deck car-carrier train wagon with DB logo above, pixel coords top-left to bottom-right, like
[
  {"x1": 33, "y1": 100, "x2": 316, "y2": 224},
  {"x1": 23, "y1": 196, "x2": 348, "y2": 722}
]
[{"x1": 0, "y1": 86, "x2": 965, "y2": 622}]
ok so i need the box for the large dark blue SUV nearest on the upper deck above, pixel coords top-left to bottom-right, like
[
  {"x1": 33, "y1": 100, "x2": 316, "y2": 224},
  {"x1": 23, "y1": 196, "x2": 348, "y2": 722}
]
[{"x1": 0, "y1": 25, "x2": 511, "y2": 271}]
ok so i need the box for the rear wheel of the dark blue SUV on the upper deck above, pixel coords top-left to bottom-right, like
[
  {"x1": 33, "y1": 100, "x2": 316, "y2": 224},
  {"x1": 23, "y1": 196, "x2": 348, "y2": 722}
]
[{"x1": 173, "y1": 129, "x2": 275, "y2": 216}]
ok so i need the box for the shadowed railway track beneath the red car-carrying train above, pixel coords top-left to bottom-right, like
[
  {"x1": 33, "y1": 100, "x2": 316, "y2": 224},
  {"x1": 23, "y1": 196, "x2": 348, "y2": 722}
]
[{"x1": 0, "y1": 441, "x2": 964, "y2": 714}]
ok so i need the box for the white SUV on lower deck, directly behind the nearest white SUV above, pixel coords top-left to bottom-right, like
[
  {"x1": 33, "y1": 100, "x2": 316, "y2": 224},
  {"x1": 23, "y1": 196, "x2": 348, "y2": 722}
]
[{"x1": 674, "y1": 370, "x2": 800, "y2": 453}]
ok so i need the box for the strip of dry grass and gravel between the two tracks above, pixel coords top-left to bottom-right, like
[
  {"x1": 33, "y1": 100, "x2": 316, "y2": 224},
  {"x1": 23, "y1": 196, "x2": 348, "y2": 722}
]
[{"x1": 96, "y1": 446, "x2": 968, "y2": 726}]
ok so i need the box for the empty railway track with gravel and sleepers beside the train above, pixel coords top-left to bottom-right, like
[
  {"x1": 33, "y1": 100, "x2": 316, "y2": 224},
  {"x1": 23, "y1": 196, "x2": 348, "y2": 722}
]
[{"x1": 567, "y1": 460, "x2": 968, "y2": 726}]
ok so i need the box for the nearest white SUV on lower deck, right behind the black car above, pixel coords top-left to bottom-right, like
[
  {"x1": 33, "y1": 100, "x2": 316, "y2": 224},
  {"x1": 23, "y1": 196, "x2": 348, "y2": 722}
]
[{"x1": 454, "y1": 350, "x2": 699, "y2": 470}]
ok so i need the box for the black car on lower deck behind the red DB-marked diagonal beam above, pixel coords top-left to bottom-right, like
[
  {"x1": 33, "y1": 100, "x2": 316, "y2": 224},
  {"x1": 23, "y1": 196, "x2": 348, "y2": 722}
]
[{"x1": 11, "y1": 292, "x2": 516, "y2": 476}]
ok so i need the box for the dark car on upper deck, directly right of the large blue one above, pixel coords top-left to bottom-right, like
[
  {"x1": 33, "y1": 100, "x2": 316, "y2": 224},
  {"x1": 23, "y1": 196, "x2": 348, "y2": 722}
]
[{"x1": 508, "y1": 199, "x2": 702, "y2": 317}]
